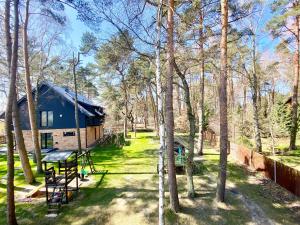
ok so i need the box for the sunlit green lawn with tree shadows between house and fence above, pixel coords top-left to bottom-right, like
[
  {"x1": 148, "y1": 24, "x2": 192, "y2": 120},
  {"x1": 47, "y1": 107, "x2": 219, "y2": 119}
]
[{"x1": 0, "y1": 133, "x2": 300, "y2": 225}]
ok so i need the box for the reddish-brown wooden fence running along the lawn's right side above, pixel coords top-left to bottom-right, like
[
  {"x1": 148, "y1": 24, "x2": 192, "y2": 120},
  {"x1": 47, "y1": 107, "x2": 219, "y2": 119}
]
[{"x1": 231, "y1": 143, "x2": 300, "y2": 197}]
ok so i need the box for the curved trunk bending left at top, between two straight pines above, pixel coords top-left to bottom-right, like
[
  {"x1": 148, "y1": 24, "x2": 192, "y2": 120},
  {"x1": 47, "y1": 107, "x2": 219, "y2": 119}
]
[{"x1": 174, "y1": 61, "x2": 196, "y2": 198}]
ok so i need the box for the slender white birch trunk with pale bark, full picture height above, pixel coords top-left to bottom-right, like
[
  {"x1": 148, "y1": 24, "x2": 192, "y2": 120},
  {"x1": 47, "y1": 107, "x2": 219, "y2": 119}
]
[{"x1": 155, "y1": 0, "x2": 165, "y2": 225}]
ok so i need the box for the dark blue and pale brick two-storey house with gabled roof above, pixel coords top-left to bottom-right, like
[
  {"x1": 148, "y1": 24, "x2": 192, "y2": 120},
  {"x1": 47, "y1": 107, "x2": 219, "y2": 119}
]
[{"x1": 1, "y1": 81, "x2": 105, "y2": 151}]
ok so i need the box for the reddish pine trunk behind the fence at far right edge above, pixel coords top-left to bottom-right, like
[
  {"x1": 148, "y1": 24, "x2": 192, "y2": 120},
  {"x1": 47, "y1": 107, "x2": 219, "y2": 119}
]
[{"x1": 289, "y1": 16, "x2": 300, "y2": 150}]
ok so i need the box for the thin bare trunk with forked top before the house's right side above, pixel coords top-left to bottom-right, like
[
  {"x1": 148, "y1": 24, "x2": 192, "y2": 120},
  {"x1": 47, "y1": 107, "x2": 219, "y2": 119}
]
[{"x1": 73, "y1": 52, "x2": 82, "y2": 154}]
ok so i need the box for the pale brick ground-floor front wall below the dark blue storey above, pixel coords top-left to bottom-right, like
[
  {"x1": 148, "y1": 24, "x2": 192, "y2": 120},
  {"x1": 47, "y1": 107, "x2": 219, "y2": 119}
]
[{"x1": 23, "y1": 128, "x2": 86, "y2": 151}]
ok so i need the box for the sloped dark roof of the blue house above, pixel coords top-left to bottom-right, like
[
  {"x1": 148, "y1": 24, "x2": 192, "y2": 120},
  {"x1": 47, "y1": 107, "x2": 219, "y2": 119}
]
[{"x1": 0, "y1": 81, "x2": 105, "y2": 118}]
